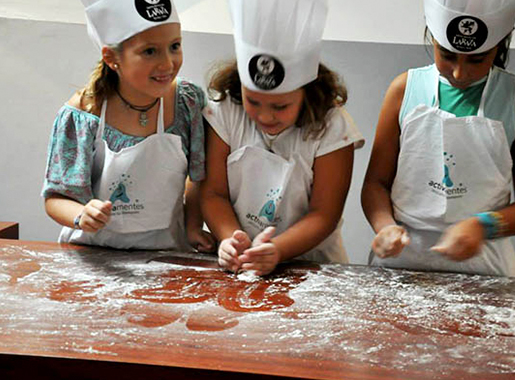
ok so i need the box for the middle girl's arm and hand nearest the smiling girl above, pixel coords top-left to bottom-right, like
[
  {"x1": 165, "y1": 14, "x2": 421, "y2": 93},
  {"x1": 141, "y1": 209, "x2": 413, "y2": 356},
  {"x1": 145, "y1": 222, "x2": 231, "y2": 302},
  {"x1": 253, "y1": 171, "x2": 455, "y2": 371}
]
[{"x1": 201, "y1": 127, "x2": 250, "y2": 272}]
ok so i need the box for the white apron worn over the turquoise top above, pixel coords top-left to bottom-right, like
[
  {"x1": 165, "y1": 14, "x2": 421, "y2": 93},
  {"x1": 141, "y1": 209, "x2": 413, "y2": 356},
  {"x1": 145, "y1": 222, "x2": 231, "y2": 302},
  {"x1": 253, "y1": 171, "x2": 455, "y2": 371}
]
[{"x1": 372, "y1": 70, "x2": 515, "y2": 275}]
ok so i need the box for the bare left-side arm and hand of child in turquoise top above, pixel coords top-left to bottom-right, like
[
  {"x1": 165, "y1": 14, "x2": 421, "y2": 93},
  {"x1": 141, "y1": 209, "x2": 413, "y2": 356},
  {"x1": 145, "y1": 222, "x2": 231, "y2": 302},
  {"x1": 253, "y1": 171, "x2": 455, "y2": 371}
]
[{"x1": 361, "y1": 73, "x2": 409, "y2": 257}]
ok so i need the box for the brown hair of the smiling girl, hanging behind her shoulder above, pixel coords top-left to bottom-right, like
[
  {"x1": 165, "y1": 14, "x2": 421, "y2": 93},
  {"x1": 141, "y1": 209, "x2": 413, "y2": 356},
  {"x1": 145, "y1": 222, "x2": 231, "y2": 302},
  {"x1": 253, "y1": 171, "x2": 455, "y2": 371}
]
[{"x1": 80, "y1": 45, "x2": 122, "y2": 113}]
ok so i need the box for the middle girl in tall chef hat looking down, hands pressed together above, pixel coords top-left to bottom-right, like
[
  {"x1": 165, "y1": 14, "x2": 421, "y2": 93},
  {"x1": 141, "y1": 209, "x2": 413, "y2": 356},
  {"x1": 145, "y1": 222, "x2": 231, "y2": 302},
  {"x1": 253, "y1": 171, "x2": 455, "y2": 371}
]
[{"x1": 202, "y1": 0, "x2": 363, "y2": 275}]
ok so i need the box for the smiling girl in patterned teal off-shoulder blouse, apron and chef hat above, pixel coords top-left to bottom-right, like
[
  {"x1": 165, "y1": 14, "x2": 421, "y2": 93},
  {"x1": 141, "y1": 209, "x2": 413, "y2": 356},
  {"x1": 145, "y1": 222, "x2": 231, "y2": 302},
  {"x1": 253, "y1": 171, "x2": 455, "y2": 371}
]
[{"x1": 43, "y1": 0, "x2": 213, "y2": 250}]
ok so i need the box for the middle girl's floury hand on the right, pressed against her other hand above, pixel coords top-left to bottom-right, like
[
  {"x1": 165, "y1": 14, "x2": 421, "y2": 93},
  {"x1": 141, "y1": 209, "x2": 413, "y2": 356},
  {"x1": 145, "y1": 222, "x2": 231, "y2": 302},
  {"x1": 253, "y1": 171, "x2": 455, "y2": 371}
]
[{"x1": 240, "y1": 227, "x2": 281, "y2": 276}]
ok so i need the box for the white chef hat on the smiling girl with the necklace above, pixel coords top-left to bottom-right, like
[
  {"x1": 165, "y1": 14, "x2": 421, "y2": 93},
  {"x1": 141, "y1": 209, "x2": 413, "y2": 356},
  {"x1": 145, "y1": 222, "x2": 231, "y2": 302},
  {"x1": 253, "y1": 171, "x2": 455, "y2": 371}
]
[{"x1": 81, "y1": 0, "x2": 179, "y2": 49}]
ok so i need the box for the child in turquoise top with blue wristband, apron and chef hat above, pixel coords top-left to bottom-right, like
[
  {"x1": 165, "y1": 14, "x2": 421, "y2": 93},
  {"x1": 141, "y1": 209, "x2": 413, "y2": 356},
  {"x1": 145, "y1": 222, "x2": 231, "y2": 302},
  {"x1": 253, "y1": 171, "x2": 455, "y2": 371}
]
[{"x1": 362, "y1": 0, "x2": 515, "y2": 276}]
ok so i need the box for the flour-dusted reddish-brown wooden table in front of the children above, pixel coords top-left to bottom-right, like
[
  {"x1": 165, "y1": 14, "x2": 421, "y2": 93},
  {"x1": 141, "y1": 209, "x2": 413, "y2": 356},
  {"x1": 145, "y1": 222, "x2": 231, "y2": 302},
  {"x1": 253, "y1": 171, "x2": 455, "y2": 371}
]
[{"x1": 0, "y1": 240, "x2": 515, "y2": 380}]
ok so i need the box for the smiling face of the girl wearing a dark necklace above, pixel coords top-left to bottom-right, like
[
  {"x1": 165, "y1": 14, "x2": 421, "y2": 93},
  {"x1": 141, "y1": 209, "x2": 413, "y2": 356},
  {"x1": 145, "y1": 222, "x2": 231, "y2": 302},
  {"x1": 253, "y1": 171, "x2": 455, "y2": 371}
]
[{"x1": 104, "y1": 23, "x2": 182, "y2": 104}]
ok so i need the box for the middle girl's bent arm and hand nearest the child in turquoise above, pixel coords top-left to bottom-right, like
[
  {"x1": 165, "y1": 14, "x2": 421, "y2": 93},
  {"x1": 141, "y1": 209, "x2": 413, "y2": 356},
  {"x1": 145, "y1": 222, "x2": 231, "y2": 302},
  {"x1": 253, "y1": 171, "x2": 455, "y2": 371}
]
[{"x1": 240, "y1": 145, "x2": 354, "y2": 275}]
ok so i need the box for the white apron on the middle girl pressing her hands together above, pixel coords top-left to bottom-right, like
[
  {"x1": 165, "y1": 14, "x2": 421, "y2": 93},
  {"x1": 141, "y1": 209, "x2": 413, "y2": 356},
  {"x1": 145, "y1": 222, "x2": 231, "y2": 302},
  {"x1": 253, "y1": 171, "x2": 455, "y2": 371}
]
[{"x1": 227, "y1": 145, "x2": 348, "y2": 263}]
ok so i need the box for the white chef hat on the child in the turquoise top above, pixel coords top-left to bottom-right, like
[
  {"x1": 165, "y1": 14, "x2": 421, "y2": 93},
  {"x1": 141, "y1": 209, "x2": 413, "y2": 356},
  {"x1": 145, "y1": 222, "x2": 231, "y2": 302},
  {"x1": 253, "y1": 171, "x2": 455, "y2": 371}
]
[{"x1": 424, "y1": 0, "x2": 515, "y2": 54}]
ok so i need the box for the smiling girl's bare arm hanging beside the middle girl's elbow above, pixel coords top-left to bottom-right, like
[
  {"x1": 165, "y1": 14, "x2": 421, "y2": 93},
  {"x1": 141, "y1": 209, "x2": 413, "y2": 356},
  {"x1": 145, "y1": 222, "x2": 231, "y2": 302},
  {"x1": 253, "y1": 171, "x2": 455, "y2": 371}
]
[{"x1": 184, "y1": 179, "x2": 215, "y2": 252}]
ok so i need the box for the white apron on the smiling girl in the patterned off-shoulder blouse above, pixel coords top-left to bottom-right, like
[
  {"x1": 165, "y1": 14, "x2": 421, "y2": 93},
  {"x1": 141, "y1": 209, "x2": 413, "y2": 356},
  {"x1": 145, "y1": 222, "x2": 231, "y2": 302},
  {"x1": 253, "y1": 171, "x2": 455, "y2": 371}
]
[{"x1": 59, "y1": 99, "x2": 188, "y2": 249}]
